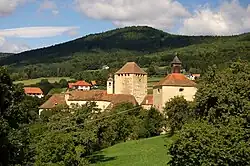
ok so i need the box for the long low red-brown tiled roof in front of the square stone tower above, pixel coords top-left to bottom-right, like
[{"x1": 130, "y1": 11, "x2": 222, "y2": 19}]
[{"x1": 68, "y1": 90, "x2": 137, "y2": 105}]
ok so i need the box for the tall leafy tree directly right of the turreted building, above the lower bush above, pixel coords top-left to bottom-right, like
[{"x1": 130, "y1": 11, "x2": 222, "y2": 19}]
[{"x1": 196, "y1": 62, "x2": 250, "y2": 123}]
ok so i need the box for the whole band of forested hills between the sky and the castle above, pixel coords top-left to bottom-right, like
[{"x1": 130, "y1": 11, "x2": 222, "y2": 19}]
[{"x1": 0, "y1": 26, "x2": 250, "y2": 80}]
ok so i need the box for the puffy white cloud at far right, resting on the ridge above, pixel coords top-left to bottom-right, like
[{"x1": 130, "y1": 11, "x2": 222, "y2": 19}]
[{"x1": 180, "y1": 0, "x2": 250, "y2": 35}]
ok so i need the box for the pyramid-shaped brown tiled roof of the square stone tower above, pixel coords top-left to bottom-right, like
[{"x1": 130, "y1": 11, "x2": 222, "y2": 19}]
[{"x1": 116, "y1": 62, "x2": 147, "y2": 75}]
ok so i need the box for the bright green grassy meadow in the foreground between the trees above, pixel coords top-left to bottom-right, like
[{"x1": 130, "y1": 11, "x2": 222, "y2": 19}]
[{"x1": 92, "y1": 136, "x2": 172, "y2": 166}]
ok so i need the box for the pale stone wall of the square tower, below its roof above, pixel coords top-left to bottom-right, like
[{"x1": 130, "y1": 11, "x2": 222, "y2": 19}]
[{"x1": 115, "y1": 74, "x2": 147, "y2": 104}]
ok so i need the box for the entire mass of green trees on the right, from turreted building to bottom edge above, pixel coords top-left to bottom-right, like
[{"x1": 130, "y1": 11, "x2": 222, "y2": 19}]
[{"x1": 170, "y1": 62, "x2": 250, "y2": 166}]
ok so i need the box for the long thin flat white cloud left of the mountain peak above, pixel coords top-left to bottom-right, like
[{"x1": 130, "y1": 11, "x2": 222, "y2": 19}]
[{"x1": 0, "y1": 26, "x2": 79, "y2": 38}]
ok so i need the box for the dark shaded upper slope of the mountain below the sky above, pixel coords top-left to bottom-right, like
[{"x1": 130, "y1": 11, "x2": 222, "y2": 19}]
[{"x1": 0, "y1": 27, "x2": 217, "y2": 65}]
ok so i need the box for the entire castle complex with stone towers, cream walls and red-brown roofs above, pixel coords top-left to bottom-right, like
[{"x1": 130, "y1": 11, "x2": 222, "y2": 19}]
[{"x1": 39, "y1": 56, "x2": 197, "y2": 113}]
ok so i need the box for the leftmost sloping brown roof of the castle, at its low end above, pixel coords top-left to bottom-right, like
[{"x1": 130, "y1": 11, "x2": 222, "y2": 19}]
[{"x1": 40, "y1": 94, "x2": 67, "y2": 109}]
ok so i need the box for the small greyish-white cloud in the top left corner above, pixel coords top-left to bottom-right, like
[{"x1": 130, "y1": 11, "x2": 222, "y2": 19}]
[{"x1": 0, "y1": 0, "x2": 30, "y2": 16}]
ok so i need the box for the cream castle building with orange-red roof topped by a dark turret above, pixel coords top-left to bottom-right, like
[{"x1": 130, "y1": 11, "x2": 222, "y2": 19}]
[{"x1": 153, "y1": 56, "x2": 197, "y2": 112}]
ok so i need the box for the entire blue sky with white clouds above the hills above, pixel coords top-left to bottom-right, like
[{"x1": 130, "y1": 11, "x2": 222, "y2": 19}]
[{"x1": 0, "y1": 0, "x2": 250, "y2": 53}]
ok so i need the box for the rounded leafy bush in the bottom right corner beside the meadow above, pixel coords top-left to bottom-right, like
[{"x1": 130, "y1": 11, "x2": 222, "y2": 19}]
[{"x1": 169, "y1": 120, "x2": 250, "y2": 166}]
